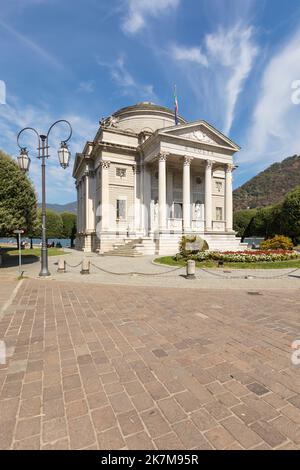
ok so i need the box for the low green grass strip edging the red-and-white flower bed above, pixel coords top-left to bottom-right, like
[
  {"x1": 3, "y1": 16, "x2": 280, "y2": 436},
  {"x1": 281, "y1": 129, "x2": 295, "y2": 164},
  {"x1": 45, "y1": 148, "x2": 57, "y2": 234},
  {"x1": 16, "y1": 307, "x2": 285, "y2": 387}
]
[{"x1": 154, "y1": 256, "x2": 300, "y2": 269}]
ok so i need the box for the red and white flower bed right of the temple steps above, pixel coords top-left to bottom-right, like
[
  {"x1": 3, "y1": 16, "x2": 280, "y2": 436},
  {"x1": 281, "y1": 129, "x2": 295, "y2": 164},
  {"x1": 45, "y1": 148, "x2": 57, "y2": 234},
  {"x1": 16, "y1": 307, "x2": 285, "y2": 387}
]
[{"x1": 175, "y1": 250, "x2": 299, "y2": 263}]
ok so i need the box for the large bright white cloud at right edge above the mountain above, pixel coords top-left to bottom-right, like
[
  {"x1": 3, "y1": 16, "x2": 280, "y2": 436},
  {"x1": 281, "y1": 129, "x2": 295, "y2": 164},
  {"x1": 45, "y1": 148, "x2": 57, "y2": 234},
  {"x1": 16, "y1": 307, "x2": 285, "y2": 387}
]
[{"x1": 239, "y1": 29, "x2": 300, "y2": 166}]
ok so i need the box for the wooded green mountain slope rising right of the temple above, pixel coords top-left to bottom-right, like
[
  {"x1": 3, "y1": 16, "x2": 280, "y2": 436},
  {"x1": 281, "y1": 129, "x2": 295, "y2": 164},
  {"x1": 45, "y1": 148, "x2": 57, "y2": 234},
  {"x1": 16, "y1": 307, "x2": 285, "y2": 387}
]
[{"x1": 233, "y1": 155, "x2": 300, "y2": 210}]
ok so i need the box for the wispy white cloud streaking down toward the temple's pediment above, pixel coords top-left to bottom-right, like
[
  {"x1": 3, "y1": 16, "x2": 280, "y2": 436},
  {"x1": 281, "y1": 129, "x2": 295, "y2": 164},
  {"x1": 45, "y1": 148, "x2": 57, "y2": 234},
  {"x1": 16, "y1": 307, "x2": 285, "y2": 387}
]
[{"x1": 170, "y1": 24, "x2": 258, "y2": 134}]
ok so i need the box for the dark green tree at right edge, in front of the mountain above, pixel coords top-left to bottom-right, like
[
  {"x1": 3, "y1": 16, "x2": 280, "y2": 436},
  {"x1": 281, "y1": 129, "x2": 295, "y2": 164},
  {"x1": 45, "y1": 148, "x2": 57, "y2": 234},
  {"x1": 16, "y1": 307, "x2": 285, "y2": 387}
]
[{"x1": 281, "y1": 186, "x2": 300, "y2": 243}]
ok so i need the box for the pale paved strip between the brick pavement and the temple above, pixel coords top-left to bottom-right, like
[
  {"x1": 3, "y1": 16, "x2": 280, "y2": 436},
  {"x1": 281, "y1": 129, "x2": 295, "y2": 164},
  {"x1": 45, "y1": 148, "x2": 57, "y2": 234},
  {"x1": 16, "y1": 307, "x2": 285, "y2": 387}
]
[{"x1": 0, "y1": 249, "x2": 300, "y2": 290}]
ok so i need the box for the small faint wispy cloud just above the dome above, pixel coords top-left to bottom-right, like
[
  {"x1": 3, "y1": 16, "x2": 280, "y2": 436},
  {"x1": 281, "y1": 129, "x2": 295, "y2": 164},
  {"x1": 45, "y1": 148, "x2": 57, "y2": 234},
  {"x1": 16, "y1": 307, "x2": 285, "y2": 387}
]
[{"x1": 97, "y1": 57, "x2": 156, "y2": 101}]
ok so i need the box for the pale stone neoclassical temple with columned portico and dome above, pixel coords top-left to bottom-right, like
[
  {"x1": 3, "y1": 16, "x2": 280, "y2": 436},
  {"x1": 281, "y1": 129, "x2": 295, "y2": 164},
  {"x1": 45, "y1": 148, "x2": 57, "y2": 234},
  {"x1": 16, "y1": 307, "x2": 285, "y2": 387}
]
[{"x1": 73, "y1": 102, "x2": 243, "y2": 254}]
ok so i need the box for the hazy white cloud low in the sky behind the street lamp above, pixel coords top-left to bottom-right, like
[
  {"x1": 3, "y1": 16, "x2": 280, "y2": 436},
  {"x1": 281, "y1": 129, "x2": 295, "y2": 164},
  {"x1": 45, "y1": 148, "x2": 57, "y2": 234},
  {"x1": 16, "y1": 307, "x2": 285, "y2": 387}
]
[{"x1": 0, "y1": 97, "x2": 97, "y2": 203}]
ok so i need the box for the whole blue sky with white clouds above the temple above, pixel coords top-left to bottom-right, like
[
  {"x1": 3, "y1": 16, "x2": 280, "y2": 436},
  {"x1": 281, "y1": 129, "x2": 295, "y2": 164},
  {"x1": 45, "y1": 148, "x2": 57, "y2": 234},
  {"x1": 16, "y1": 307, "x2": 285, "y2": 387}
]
[{"x1": 0, "y1": 0, "x2": 300, "y2": 203}]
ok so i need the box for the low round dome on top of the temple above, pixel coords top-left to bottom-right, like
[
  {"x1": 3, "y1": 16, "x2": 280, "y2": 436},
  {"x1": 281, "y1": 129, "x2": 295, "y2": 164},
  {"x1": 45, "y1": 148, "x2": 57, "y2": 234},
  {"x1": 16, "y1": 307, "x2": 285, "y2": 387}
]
[{"x1": 113, "y1": 101, "x2": 186, "y2": 134}]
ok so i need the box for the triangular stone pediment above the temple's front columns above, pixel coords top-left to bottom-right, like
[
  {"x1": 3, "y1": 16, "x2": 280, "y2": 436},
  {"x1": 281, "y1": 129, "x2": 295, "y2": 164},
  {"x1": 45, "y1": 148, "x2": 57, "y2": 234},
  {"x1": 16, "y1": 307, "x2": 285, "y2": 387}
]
[{"x1": 159, "y1": 121, "x2": 240, "y2": 151}]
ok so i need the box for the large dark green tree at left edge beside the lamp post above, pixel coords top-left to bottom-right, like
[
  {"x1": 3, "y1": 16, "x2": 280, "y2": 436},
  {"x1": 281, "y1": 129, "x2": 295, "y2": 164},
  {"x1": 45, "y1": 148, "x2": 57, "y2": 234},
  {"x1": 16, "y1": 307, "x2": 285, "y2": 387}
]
[{"x1": 0, "y1": 150, "x2": 37, "y2": 237}]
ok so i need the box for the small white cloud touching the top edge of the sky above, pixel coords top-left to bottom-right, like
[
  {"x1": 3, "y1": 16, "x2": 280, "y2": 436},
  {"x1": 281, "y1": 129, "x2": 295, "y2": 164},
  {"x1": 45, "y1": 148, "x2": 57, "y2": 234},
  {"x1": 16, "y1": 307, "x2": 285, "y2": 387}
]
[{"x1": 122, "y1": 0, "x2": 180, "y2": 34}]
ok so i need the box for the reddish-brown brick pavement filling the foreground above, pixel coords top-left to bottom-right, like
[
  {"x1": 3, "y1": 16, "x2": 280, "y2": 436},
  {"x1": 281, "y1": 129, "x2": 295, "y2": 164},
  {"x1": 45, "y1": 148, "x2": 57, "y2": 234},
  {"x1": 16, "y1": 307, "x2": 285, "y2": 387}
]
[{"x1": 0, "y1": 280, "x2": 300, "y2": 449}]
